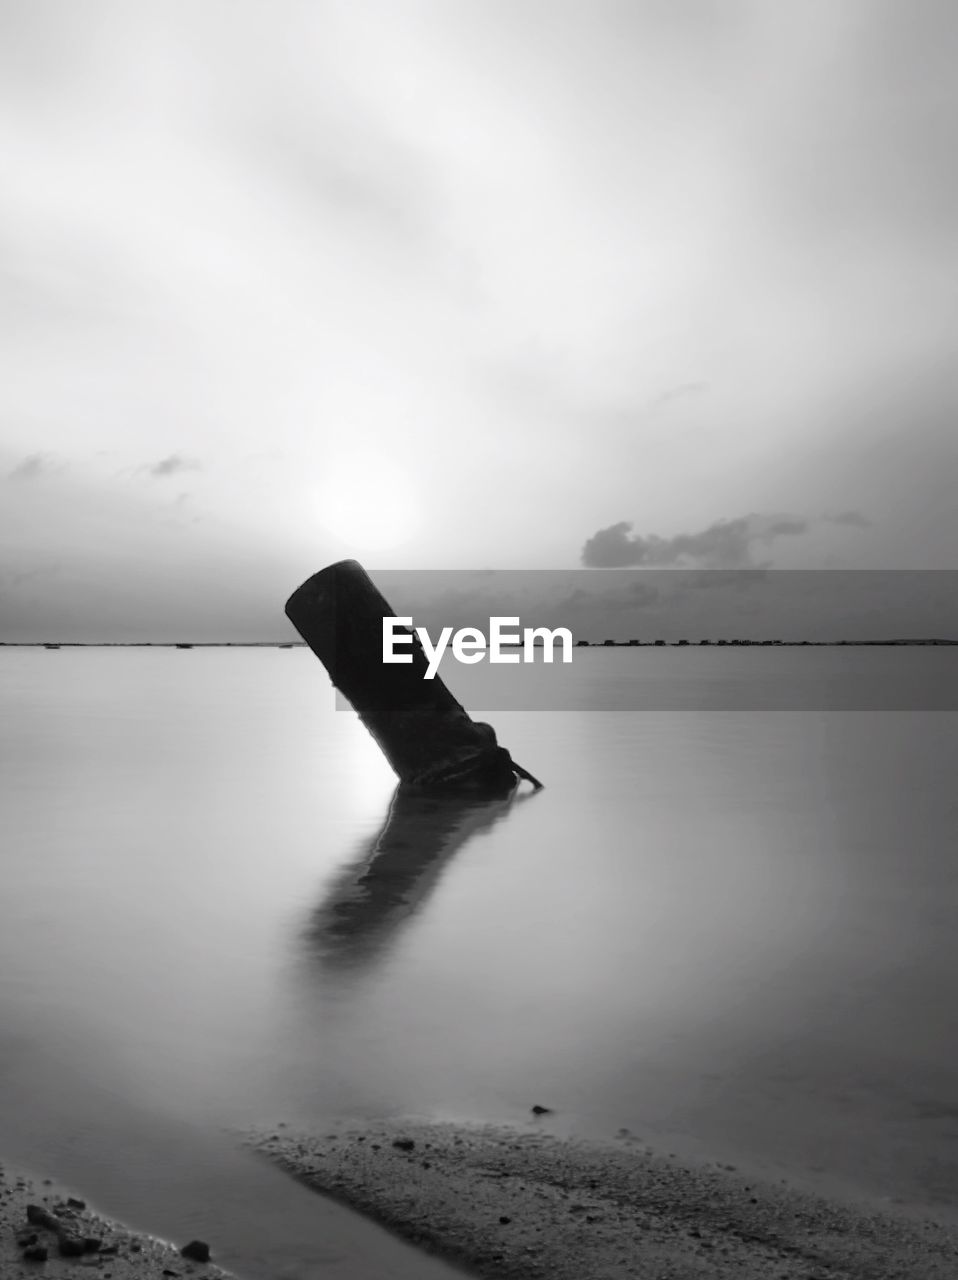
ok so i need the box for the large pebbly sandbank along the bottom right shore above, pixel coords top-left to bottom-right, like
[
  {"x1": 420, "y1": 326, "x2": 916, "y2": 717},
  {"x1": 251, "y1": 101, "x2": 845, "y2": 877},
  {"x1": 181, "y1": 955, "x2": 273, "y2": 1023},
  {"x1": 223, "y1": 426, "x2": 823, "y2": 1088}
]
[{"x1": 246, "y1": 1121, "x2": 958, "y2": 1280}]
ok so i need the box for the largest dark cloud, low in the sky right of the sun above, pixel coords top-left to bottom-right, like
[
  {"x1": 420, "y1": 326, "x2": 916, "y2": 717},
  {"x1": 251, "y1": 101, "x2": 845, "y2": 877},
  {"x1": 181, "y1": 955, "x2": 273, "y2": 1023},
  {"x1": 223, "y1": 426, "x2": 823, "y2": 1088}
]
[{"x1": 581, "y1": 513, "x2": 808, "y2": 568}]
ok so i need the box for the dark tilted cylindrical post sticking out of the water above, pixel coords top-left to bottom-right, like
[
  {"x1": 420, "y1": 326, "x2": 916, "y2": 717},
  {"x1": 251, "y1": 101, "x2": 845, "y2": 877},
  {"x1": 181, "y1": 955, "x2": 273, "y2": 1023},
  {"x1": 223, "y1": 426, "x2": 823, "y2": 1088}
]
[{"x1": 286, "y1": 561, "x2": 542, "y2": 794}]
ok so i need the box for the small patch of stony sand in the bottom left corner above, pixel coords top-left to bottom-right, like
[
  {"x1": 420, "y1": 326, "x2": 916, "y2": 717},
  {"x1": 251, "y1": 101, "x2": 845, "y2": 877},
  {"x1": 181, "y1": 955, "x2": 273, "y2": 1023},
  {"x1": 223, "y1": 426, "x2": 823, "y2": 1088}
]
[{"x1": 0, "y1": 1164, "x2": 234, "y2": 1280}]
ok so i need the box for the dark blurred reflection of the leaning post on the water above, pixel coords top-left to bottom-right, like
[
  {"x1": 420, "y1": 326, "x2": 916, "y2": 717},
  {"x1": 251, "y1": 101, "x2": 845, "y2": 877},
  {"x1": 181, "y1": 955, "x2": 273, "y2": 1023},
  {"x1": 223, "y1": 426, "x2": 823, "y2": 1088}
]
[{"x1": 307, "y1": 783, "x2": 532, "y2": 968}]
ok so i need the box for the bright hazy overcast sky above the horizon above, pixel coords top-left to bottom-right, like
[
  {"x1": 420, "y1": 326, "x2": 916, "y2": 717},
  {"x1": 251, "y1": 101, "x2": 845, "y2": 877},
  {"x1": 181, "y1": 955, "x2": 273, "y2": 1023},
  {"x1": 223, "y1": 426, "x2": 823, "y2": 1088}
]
[{"x1": 0, "y1": 0, "x2": 958, "y2": 641}]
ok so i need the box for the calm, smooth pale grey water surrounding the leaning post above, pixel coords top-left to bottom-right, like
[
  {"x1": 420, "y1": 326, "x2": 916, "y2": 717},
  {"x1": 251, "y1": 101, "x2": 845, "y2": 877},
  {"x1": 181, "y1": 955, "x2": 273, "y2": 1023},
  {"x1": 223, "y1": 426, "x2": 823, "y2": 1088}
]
[{"x1": 0, "y1": 649, "x2": 958, "y2": 1276}]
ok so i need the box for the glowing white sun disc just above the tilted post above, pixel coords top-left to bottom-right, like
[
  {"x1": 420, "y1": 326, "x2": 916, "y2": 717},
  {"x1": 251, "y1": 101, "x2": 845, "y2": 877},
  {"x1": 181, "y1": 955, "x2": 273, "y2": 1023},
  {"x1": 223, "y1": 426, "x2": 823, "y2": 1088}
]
[{"x1": 316, "y1": 453, "x2": 420, "y2": 552}]
